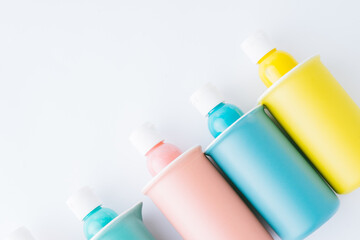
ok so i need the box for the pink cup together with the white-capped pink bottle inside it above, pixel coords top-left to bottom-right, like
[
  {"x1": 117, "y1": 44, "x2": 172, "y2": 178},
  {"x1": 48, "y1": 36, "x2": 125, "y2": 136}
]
[{"x1": 130, "y1": 123, "x2": 272, "y2": 240}]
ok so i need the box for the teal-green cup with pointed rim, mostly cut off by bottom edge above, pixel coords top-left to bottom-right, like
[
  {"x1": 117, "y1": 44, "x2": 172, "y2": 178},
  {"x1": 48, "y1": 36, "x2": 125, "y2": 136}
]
[{"x1": 91, "y1": 203, "x2": 155, "y2": 240}]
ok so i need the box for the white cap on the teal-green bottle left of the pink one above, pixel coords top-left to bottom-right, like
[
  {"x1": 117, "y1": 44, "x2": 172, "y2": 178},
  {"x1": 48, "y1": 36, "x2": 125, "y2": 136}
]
[{"x1": 66, "y1": 187, "x2": 102, "y2": 221}]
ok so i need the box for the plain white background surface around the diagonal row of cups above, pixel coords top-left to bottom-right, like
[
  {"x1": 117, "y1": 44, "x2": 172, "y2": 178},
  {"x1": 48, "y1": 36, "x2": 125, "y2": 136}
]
[{"x1": 0, "y1": 0, "x2": 360, "y2": 240}]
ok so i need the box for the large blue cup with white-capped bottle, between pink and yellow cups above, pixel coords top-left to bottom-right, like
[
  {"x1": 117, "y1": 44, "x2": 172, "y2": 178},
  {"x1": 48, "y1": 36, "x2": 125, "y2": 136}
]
[{"x1": 191, "y1": 84, "x2": 339, "y2": 240}]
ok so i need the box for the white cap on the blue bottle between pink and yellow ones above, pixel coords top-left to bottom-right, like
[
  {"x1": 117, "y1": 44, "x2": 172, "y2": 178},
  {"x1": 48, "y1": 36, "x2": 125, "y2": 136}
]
[{"x1": 190, "y1": 83, "x2": 224, "y2": 116}]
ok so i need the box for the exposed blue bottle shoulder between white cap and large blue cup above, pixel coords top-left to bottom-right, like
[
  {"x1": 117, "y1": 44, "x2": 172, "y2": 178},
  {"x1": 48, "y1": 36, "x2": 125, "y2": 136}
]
[{"x1": 208, "y1": 103, "x2": 243, "y2": 137}]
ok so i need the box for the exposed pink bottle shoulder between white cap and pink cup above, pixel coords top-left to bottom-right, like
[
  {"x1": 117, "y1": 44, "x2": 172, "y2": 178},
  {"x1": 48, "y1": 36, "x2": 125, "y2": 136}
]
[{"x1": 145, "y1": 141, "x2": 182, "y2": 176}]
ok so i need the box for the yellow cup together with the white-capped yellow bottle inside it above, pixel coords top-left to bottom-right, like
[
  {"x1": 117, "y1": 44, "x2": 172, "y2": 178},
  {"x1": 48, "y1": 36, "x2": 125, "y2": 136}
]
[{"x1": 242, "y1": 32, "x2": 360, "y2": 194}]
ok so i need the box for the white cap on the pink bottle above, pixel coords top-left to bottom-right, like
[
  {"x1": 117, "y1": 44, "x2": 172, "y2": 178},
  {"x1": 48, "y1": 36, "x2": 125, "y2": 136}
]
[{"x1": 129, "y1": 122, "x2": 165, "y2": 156}]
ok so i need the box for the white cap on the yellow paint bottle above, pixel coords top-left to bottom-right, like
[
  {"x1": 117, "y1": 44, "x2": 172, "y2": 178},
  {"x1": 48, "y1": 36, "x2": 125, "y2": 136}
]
[{"x1": 241, "y1": 31, "x2": 275, "y2": 63}]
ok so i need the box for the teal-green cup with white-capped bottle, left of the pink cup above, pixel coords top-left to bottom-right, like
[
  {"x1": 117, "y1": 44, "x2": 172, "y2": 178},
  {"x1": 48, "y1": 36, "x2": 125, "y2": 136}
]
[{"x1": 67, "y1": 187, "x2": 155, "y2": 240}]
